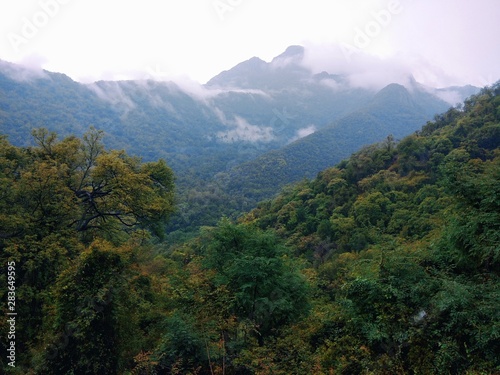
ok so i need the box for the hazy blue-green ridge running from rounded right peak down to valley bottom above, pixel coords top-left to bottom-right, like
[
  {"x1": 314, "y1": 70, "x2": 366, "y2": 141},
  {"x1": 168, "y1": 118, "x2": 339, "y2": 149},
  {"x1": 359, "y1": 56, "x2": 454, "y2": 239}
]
[{"x1": 168, "y1": 82, "x2": 462, "y2": 238}]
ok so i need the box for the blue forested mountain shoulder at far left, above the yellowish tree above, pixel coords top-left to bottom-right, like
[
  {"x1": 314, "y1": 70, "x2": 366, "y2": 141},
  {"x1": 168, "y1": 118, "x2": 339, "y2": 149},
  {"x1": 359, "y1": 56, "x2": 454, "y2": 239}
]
[{"x1": 0, "y1": 61, "x2": 120, "y2": 146}]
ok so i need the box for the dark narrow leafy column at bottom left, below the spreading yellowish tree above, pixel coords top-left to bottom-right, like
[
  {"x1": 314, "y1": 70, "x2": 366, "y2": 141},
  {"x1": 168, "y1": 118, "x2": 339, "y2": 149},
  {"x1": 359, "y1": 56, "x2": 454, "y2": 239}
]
[{"x1": 40, "y1": 243, "x2": 125, "y2": 374}]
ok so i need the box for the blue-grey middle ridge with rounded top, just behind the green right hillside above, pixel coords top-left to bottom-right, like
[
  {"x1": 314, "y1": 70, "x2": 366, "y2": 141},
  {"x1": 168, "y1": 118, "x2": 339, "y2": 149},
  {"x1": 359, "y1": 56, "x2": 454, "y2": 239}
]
[{"x1": 223, "y1": 84, "x2": 458, "y2": 202}]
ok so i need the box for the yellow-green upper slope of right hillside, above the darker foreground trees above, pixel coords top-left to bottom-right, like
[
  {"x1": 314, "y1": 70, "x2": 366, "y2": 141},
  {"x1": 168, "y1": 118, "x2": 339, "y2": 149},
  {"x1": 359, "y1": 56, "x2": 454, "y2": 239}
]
[{"x1": 249, "y1": 84, "x2": 500, "y2": 258}]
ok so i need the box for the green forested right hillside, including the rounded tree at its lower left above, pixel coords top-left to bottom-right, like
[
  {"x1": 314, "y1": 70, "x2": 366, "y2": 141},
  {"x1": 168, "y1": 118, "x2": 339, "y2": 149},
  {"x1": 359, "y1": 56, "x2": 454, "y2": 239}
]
[{"x1": 162, "y1": 85, "x2": 500, "y2": 374}]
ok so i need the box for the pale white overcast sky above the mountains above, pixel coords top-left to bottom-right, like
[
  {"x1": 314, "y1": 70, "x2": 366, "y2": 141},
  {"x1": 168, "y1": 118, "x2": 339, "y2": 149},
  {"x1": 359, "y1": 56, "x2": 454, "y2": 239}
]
[{"x1": 0, "y1": 0, "x2": 500, "y2": 87}]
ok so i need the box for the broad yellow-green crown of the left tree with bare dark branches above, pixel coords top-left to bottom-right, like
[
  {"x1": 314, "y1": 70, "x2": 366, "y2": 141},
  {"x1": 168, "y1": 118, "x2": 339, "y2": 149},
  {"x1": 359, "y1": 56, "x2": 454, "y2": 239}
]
[{"x1": 3, "y1": 128, "x2": 174, "y2": 243}]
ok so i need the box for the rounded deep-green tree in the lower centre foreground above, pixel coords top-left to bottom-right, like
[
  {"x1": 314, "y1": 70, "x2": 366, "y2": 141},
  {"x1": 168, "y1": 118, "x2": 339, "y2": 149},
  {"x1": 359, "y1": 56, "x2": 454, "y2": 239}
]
[{"x1": 205, "y1": 221, "x2": 307, "y2": 340}]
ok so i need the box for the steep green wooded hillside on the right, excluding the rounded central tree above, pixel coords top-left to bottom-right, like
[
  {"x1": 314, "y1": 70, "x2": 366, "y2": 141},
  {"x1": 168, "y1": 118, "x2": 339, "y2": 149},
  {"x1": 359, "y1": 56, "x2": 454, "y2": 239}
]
[{"x1": 233, "y1": 82, "x2": 500, "y2": 374}]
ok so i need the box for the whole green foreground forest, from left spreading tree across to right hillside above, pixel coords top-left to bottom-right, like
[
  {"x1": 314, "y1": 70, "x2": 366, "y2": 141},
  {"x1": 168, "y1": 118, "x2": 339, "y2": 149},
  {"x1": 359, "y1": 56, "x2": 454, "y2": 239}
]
[{"x1": 0, "y1": 83, "x2": 500, "y2": 375}]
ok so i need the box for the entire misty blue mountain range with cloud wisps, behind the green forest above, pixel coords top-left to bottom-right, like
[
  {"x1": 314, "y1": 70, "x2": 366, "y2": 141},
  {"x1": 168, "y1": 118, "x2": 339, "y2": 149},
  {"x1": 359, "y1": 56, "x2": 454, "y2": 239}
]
[{"x1": 0, "y1": 46, "x2": 480, "y2": 235}]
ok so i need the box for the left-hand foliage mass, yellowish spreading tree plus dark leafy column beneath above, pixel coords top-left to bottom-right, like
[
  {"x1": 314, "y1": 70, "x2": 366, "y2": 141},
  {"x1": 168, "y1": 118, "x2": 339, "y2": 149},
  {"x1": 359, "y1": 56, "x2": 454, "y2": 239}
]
[{"x1": 0, "y1": 129, "x2": 173, "y2": 373}]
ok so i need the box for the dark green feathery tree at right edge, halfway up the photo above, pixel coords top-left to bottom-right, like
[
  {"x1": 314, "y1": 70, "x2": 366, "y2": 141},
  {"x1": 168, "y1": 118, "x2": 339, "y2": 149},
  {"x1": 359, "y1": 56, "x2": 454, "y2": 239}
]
[{"x1": 442, "y1": 150, "x2": 500, "y2": 274}]
